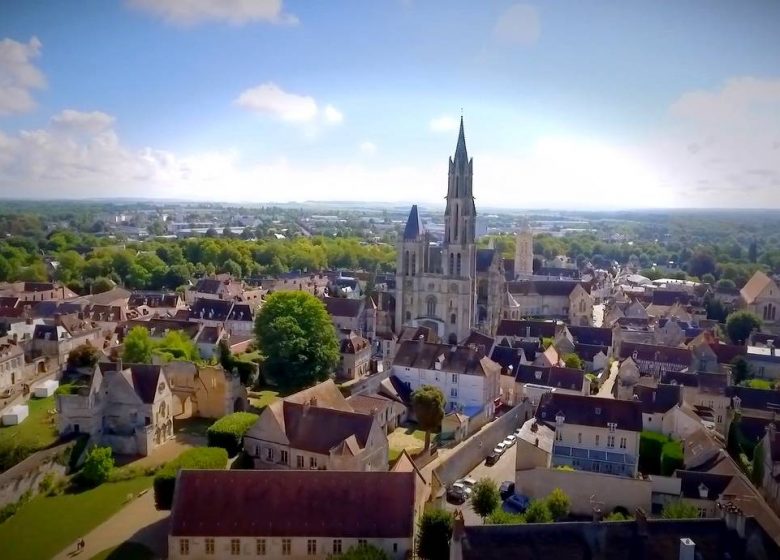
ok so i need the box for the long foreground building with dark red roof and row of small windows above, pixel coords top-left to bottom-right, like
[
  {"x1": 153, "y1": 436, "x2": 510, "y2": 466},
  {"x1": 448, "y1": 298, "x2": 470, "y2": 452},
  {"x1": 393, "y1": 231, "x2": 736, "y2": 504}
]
[{"x1": 168, "y1": 470, "x2": 420, "y2": 560}]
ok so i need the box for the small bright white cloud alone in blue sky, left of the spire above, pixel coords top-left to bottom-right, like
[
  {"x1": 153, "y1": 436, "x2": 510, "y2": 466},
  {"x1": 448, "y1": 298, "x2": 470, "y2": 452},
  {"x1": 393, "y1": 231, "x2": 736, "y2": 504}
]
[{"x1": 234, "y1": 82, "x2": 344, "y2": 125}]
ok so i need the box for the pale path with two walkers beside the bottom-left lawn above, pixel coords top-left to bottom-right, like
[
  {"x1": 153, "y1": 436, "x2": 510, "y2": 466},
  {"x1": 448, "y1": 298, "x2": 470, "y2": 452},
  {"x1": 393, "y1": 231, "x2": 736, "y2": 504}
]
[{"x1": 54, "y1": 489, "x2": 170, "y2": 560}]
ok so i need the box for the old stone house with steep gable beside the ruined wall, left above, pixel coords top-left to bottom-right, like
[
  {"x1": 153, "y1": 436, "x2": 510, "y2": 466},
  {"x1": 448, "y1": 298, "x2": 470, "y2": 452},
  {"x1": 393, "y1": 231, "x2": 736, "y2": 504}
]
[{"x1": 56, "y1": 362, "x2": 173, "y2": 455}]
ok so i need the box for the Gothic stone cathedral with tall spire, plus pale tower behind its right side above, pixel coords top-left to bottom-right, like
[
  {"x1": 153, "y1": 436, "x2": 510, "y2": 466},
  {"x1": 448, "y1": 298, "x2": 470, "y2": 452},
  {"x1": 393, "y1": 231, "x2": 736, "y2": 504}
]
[{"x1": 395, "y1": 117, "x2": 533, "y2": 344}]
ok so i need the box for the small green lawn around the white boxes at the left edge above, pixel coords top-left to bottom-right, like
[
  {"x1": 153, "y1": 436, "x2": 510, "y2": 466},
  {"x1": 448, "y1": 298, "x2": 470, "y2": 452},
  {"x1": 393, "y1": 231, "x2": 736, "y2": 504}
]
[{"x1": 0, "y1": 396, "x2": 58, "y2": 470}]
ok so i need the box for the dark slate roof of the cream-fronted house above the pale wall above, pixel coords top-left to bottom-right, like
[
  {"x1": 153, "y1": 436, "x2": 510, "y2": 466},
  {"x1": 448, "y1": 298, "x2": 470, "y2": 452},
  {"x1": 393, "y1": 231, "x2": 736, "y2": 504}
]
[{"x1": 536, "y1": 393, "x2": 642, "y2": 432}]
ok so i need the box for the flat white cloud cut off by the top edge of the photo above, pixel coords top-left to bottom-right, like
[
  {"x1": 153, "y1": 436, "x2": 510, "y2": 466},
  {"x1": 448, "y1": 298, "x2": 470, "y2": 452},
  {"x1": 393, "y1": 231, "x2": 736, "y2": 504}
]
[{"x1": 128, "y1": 0, "x2": 298, "y2": 25}]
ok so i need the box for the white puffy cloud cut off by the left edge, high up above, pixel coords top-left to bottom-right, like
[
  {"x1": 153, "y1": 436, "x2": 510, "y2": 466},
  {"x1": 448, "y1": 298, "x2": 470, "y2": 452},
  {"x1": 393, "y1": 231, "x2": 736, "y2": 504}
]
[{"x1": 0, "y1": 37, "x2": 46, "y2": 115}]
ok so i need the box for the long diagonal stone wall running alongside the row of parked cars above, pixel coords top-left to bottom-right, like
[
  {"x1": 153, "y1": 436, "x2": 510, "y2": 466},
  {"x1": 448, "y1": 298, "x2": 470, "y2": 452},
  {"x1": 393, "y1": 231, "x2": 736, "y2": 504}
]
[{"x1": 434, "y1": 404, "x2": 525, "y2": 485}]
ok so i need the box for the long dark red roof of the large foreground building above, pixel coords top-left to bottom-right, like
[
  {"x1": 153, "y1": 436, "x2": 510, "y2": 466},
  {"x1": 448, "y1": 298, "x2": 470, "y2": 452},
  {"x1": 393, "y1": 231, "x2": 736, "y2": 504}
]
[{"x1": 170, "y1": 470, "x2": 416, "y2": 539}]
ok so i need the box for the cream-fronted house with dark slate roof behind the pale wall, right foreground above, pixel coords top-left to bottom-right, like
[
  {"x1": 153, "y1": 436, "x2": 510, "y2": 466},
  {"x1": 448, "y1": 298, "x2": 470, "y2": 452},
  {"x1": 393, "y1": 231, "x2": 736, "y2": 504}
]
[{"x1": 536, "y1": 392, "x2": 642, "y2": 477}]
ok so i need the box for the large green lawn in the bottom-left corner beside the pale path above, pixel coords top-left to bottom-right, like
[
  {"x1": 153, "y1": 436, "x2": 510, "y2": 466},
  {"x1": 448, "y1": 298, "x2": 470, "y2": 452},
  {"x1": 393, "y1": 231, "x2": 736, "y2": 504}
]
[{"x1": 0, "y1": 476, "x2": 152, "y2": 560}]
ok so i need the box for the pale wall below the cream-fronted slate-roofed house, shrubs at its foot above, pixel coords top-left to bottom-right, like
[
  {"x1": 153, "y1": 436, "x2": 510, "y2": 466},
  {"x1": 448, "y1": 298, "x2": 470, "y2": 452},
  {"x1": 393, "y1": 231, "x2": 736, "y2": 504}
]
[{"x1": 515, "y1": 468, "x2": 652, "y2": 516}]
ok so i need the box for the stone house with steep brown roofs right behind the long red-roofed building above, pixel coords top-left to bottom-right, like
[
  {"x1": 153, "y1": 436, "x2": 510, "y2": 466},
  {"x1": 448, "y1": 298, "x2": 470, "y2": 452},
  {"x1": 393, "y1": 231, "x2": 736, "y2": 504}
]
[{"x1": 244, "y1": 380, "x2": 388, "y2": 471}]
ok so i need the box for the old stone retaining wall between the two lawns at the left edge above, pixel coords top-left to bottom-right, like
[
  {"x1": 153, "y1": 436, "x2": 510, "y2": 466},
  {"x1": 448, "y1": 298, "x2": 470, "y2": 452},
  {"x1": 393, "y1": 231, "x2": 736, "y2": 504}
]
[{"x1": 0, "y1": 440, "x2": 77, "y2": 508}]
